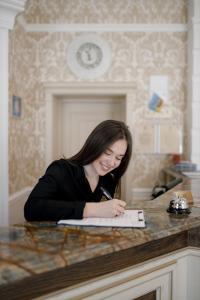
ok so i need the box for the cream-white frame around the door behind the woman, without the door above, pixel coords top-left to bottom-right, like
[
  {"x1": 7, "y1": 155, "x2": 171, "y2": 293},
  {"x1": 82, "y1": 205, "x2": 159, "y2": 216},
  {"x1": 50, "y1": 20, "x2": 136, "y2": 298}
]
[{"x1": 45, "y1": 82, "x2": 135, "y2": 200}]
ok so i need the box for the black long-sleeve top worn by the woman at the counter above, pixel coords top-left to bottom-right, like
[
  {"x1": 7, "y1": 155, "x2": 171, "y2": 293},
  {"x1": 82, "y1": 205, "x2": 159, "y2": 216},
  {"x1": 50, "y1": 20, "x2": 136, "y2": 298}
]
[{"x1": 24, "y1": 159, "x2": 117, "y2": 221}]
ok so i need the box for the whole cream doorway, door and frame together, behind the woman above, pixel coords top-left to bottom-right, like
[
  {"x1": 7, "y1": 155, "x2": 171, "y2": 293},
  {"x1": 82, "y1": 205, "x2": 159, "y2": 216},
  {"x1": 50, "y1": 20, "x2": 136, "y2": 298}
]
[{"x1": 45, "y1": 82, "x2": 134, "y2": 202}]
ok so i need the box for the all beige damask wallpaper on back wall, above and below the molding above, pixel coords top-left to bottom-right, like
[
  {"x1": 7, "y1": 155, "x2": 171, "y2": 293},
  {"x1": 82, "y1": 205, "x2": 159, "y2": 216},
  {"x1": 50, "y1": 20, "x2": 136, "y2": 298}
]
[{"x1": 9, "y1": 0, "x2": 187, "y2": 199}]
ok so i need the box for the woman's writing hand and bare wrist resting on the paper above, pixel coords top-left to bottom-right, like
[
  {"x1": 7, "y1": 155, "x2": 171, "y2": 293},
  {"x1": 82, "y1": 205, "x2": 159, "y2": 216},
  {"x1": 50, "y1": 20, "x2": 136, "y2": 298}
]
[{"x1": 83, "y1": 199, "x2": 126, "y2": 218}]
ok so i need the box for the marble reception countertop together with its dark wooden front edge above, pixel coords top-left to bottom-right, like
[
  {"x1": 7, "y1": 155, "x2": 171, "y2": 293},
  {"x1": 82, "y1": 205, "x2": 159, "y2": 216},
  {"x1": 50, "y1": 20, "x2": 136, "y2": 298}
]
[{"x1": 0, "y1": 175, "x2": 200, "y2": 300}]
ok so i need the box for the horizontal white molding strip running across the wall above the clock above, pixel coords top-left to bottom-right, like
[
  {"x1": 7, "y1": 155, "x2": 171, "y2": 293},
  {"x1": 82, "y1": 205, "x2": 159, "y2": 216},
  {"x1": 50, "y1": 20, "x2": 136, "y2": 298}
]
[{"x1": 18, "y1": 15, "x2": 187, "y2": 32}]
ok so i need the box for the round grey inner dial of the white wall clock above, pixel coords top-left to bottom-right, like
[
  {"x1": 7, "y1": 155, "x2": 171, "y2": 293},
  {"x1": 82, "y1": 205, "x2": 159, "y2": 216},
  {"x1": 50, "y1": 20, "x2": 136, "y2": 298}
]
[{"x1": 76, "y1": 42, "x2": 103, "y2": 69}]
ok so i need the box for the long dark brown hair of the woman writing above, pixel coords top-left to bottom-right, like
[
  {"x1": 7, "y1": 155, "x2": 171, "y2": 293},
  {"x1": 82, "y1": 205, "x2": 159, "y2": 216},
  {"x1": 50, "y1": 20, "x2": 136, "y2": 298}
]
[{"x1": 69, "y1": 120, "x2": 132, "y2": 179}]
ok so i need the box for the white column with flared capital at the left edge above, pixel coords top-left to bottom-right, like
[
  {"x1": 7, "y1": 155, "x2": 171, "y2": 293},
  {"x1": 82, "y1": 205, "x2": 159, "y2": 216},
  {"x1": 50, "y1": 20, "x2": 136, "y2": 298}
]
[{"x1": 0, "y1": 0, "x2": 25, "y2": 226}]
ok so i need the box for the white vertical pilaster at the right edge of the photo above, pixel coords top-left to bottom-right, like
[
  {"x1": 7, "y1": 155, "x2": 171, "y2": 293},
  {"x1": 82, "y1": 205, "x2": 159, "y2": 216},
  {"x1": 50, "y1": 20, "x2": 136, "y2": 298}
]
[{"x1": 188, "y1": 0, "x2": 200, "y2": 170}]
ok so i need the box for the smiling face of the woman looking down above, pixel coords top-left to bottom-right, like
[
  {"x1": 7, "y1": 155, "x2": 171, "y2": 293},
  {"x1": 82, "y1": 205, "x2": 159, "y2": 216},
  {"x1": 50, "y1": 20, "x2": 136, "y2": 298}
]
[{"x1": 91, "y1": 139, "x2": 127, "y2": 176}]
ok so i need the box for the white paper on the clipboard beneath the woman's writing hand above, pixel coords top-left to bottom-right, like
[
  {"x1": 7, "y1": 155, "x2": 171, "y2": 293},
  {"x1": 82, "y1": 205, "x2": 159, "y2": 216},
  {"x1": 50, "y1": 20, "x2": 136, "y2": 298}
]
[{"x1": 57, "y1": 210, "x2": 145, "y2": 227}]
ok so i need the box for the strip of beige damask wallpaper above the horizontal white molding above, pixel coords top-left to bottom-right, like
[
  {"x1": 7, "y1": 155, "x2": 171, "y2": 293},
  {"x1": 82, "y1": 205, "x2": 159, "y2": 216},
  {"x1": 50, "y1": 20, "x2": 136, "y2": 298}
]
[{"x1": 25, "y1": 0, "x2": 187, "y2": 23}]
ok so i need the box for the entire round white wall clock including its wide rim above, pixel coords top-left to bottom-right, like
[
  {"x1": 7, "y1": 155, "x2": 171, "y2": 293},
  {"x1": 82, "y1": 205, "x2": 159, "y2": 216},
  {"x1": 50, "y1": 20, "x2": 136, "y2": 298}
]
[{"x1": 67, "y1": 34, "x2": 111, "y2": 79}]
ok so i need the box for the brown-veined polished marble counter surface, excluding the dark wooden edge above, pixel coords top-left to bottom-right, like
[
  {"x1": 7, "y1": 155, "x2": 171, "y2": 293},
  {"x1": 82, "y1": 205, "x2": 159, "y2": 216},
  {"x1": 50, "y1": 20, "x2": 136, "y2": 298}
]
[{"x1": 0, "y1": 181, "x2": 200, "y2": 285}]
